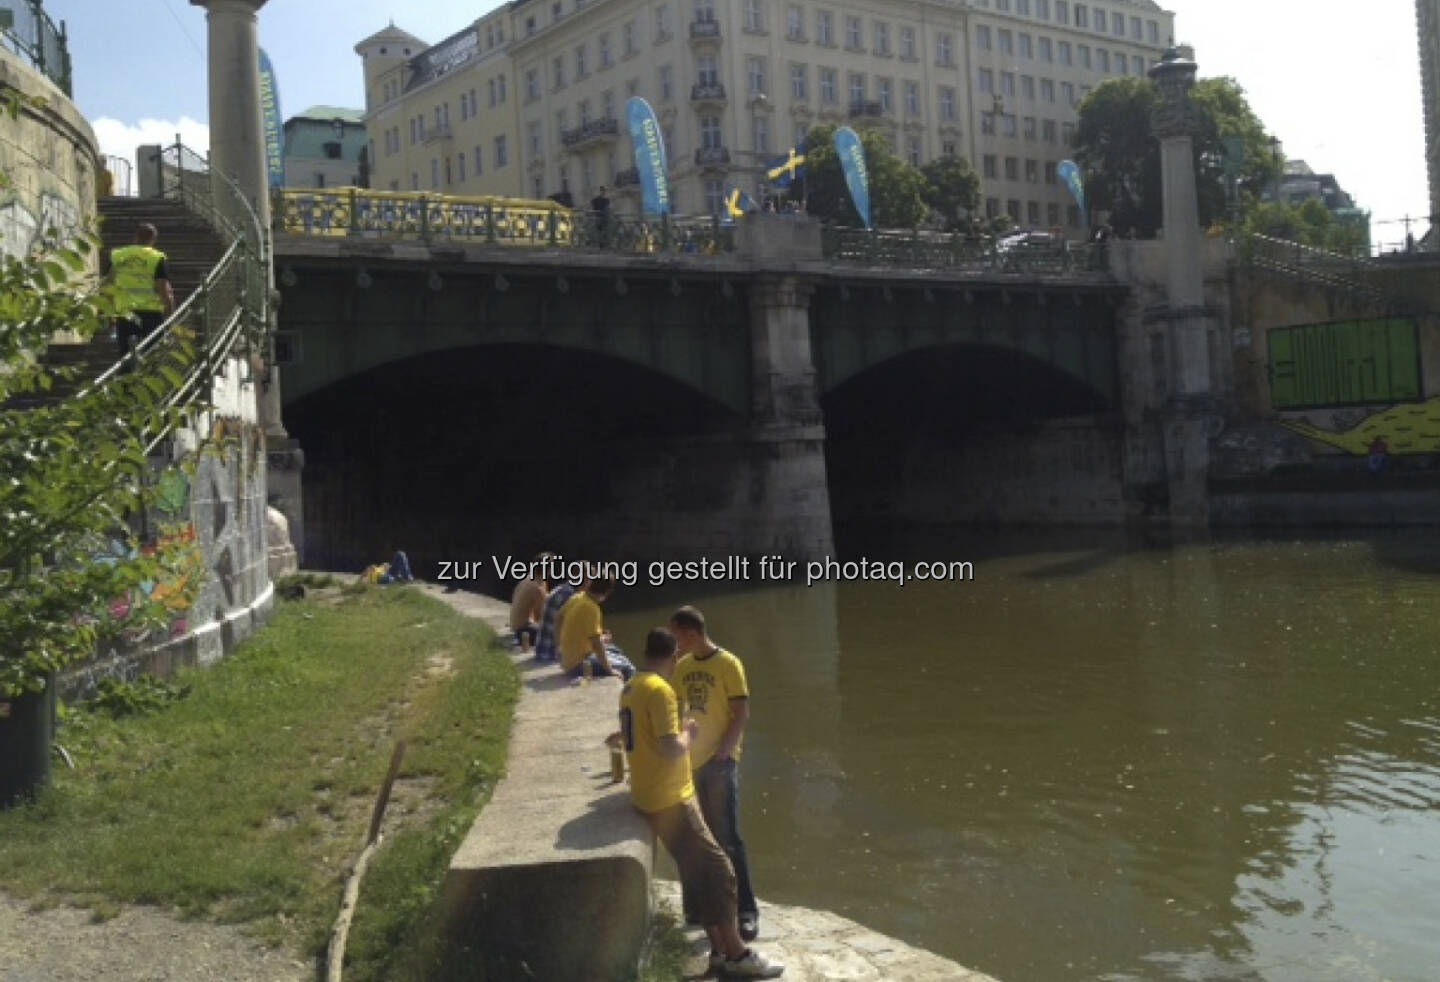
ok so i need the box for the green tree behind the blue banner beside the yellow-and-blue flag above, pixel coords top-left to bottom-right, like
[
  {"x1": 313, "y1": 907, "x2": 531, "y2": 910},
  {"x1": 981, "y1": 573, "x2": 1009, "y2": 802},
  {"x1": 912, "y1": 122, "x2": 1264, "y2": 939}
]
[{"x1": 791, "y1": 124, "x2": 929, "y2": 229}]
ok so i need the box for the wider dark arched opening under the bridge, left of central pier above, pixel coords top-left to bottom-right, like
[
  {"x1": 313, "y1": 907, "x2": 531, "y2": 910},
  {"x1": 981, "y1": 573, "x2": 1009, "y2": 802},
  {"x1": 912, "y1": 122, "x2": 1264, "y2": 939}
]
[{"x1": 285, "y1": 344, "x2": 740, "y2": 589}]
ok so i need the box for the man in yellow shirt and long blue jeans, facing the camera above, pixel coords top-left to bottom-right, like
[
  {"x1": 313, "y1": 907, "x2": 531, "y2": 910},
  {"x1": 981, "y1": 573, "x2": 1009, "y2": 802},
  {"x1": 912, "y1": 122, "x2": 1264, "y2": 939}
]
[{"x1": 670, "y1": 606, "x2": 760, "y2": 942}]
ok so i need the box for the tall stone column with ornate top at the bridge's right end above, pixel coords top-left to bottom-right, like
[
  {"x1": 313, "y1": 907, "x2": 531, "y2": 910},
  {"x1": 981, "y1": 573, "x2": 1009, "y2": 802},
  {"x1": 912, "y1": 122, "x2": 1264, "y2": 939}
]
[{"x1": 1151, "y1": 48, "x2": 1215, "y2": 528}]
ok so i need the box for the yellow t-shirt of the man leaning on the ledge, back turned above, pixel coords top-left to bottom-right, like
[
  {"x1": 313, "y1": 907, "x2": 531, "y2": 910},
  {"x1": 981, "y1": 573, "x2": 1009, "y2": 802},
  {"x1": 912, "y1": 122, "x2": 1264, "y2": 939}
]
[{"x1": 621, "y1": 671, "x2": 696, "y2": 812}]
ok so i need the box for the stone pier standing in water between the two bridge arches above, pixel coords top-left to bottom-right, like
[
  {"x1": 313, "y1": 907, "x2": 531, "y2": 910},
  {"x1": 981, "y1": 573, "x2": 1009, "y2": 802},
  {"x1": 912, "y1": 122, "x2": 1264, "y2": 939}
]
[{"x1": 743, "y1": 275, "x2": 835, "y2": 560}]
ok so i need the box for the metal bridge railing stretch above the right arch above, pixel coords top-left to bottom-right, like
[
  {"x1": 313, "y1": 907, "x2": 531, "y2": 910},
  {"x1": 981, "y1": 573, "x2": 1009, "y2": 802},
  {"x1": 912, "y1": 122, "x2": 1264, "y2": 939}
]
[{"x1": 821, "y1": 226, "x2": 1106, "y2": 274}]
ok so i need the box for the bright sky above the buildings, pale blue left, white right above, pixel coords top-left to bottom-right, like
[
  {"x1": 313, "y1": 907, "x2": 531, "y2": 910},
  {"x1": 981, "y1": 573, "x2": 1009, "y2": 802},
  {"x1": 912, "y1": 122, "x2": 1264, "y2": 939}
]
[{"x1": 45, "y1": 0, "x2": 1428, "y2": 249}]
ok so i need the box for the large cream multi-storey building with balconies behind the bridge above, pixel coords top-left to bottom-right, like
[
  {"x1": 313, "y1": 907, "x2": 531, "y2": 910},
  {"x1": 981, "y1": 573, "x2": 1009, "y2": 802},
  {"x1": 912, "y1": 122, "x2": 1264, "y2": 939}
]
[{"x1": 356, "y1": 0, "x2": 1174, "y2": 230}]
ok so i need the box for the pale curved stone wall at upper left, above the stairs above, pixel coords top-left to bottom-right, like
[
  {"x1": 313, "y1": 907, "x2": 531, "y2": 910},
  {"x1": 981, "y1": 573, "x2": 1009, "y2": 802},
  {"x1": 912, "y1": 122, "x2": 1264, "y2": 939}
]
[{"x1": 0, "y1": 48, "x2": 99, "y2": 263}]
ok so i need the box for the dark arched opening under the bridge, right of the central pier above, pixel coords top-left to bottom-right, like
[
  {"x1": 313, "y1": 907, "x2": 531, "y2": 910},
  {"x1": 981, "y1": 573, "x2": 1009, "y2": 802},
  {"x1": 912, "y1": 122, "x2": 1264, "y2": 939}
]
[{"x1": 822, "y1": 344, "x2": 1122, "y2": 554}]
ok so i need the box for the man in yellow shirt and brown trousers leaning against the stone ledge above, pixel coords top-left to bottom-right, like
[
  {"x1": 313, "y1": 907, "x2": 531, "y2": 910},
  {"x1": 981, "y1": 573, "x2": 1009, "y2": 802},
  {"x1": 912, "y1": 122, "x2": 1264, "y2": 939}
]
[{"x1": 611, "y1": 628, "x2": 785, "y2": 979}]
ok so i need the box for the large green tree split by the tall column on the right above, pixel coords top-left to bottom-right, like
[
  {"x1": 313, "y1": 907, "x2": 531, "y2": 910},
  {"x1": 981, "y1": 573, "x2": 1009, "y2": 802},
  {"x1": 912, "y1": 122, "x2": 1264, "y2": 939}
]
[{"x1": 1074, "y1": 76, "x2": 1280, "y2": 236}]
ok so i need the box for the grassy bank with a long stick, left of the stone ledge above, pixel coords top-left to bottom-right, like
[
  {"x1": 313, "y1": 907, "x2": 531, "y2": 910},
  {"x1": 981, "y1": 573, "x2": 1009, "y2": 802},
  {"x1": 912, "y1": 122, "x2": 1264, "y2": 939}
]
[{"x1": 0, "y1": 587, "x2": 517, "y2": 981}]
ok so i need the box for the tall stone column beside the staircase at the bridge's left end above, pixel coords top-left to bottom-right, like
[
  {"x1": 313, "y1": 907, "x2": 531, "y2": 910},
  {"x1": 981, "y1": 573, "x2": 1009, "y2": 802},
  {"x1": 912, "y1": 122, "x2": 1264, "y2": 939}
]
[{"x1": 190, "y1": 0, "x2": 304, "y2": 555}]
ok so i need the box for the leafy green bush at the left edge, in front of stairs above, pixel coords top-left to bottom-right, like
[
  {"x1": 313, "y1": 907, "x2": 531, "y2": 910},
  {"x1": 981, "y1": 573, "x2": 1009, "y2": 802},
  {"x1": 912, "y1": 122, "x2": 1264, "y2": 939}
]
[{"x1": 0, "y1": 139, "x2": 203, "y2": 694}]
